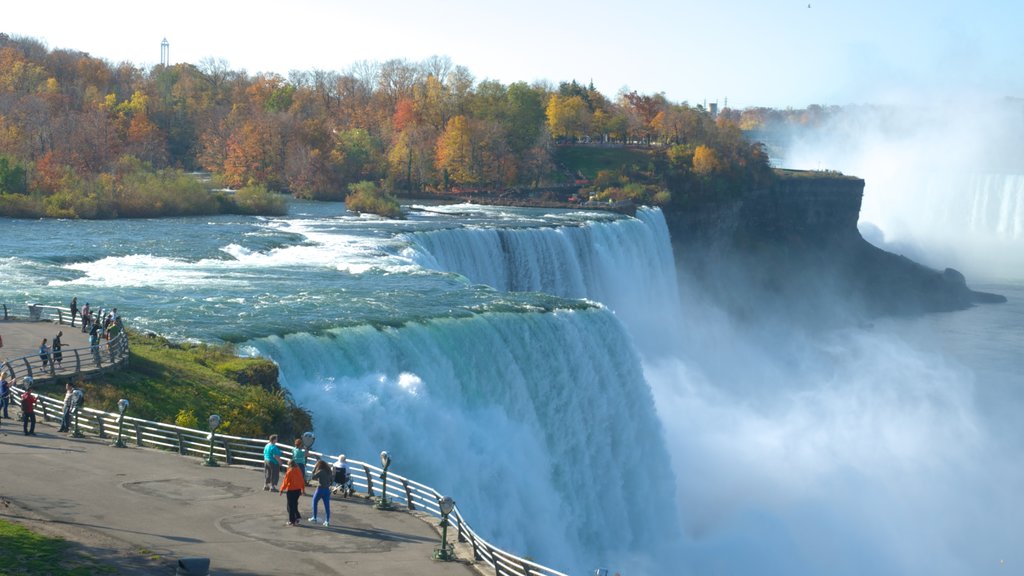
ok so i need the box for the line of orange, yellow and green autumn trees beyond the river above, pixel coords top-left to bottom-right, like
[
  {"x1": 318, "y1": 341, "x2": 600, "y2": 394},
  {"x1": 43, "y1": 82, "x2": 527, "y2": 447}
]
[{"x1": 0, "y1": 34, "x2": 770, "y2": 217}]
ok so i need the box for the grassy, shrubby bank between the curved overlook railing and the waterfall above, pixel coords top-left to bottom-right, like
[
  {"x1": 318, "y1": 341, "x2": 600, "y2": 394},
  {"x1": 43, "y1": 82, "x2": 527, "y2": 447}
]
[{"x1": 75, "y1": 330, "x2": 312, "y2": 441}]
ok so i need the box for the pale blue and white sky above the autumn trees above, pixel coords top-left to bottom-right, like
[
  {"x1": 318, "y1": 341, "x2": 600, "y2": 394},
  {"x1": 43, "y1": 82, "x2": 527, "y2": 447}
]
[{"x1": 0, "y1": 0, "x2": 1024, "y2": 109}]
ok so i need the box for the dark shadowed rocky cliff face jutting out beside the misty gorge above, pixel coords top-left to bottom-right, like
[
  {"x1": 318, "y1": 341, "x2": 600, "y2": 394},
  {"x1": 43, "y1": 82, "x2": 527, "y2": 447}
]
[{"x1": 666, "y1": 171, "x2": 1000, "y2": 322}]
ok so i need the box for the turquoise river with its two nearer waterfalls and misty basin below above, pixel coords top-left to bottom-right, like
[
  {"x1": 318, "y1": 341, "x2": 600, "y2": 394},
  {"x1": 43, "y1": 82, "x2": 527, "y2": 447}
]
[{"x1": 0, "y1": 202, "x2": 1024, "y2": 575}]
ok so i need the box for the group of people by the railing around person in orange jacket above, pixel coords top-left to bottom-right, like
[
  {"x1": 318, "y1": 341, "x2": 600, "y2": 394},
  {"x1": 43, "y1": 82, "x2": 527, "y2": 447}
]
[{"x1": 263, "y1": 435, "x2": 352, "y2": 526}]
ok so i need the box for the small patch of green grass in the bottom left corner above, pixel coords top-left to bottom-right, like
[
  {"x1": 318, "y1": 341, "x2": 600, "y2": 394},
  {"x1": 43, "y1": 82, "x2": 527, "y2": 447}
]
[{"x1": 0, "y1": 520, "x2": 117, "y2": 576}]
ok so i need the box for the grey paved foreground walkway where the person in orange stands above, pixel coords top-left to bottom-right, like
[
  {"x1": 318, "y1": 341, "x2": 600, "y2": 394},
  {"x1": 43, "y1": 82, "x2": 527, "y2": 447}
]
[{"x1": 0, "y1": 414, "x2": 477, "y2": 576}]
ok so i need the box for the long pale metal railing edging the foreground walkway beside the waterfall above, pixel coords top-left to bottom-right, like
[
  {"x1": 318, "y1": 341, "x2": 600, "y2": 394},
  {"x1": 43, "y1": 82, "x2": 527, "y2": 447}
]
[{"x1": 11, "y1": 387, "x2": 566, "y2": 576}]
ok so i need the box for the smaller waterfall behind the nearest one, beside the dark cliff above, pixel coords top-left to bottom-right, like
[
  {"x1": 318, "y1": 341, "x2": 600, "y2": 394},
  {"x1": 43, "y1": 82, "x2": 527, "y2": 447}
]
[{"x1": 409, "y1": 208, "x2": 681, "y2": 356}]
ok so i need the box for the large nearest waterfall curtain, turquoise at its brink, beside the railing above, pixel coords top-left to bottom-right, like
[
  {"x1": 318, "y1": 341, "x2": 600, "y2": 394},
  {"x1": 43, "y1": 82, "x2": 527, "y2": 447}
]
[{"x1": 251, "y1": 307, "x2": 678, "y2": 573}]
